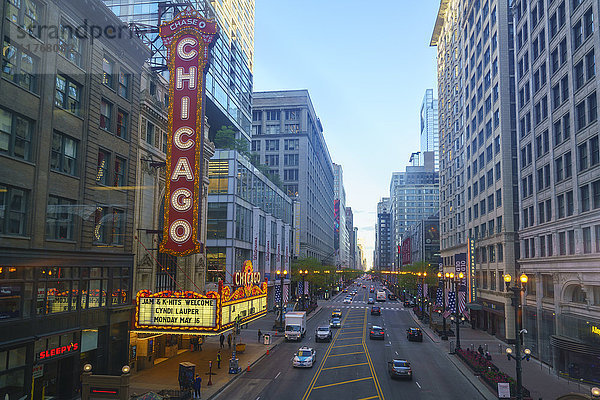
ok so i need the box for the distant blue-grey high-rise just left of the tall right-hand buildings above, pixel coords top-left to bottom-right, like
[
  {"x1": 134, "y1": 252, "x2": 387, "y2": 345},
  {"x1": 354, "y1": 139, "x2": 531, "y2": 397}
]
[{"x1": 390, "y1": 152, "x2": 440, "y2": 266}]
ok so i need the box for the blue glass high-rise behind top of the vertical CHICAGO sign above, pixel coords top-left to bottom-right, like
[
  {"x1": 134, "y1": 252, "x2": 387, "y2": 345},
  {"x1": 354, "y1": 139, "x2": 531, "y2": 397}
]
[{"x1": 103, "y1": 0, "x2": 254, "y2": 141}]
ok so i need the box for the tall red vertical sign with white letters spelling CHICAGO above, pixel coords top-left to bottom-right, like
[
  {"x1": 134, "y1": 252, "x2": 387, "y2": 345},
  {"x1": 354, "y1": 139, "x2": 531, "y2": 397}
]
[{"x1": 159, "y1": 7, "x2": 218, "y2": 256}]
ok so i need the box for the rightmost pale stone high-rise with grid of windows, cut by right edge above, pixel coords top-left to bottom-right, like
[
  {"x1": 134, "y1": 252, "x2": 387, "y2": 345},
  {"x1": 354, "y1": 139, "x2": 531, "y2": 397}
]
[{"x1": 513, "y1": 0, "x2": 600, "y2": 382}]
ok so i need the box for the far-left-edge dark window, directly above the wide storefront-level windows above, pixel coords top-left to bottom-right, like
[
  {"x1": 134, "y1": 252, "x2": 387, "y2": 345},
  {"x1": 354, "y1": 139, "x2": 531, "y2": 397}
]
[{"x1": 0, "y1": 184, "x2": 28, "y2": 236}]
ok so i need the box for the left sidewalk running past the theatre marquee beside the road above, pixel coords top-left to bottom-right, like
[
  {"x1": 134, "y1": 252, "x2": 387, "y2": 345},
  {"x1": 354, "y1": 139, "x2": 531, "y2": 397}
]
[{"x1": 130, "y1": 305, "x2": 322, "y2": 399}]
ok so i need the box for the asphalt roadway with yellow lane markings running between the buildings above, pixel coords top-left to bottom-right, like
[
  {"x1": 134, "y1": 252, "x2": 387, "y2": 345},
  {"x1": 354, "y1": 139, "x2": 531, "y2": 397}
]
[{"x1": 217, "y1": 281, "x2": 482, "y2": 400}]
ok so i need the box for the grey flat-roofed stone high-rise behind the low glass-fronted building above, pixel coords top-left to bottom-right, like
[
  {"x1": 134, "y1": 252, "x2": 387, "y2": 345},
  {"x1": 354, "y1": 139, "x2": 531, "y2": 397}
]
[{"x1": 252, "y1": 90, "x2": 335, "y2": 264}]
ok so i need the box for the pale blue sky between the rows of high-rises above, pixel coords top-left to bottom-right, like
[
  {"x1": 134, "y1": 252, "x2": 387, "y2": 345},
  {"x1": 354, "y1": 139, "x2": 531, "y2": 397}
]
[{"x1": 253, "y1": 0, "x2": 439, "y2": 266}]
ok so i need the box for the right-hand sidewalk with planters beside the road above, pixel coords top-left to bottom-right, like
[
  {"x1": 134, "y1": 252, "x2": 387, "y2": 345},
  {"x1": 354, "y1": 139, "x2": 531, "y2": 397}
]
[{"x1": 410, "y1": 312, "x2": 591, "y2": 400}]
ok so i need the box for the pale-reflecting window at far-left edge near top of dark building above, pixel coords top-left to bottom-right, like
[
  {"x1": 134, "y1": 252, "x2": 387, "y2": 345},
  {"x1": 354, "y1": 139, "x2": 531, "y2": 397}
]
[{"x1": 2, "y1": 38, "x2": 38, "y2": 93}]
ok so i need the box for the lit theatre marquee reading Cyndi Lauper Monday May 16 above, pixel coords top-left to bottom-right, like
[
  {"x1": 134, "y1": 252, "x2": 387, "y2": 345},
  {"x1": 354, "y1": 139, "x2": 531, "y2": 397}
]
[{"x1": 135, "y1": 260, "x2": 267, "y2": 334}]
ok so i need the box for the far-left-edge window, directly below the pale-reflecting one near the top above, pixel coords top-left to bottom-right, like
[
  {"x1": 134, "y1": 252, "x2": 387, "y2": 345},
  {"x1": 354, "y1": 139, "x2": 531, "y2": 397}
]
[{"x1": 0, "y1": 108, "x2": 33, "y2": 160}]
